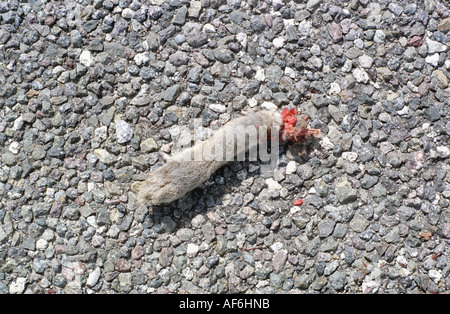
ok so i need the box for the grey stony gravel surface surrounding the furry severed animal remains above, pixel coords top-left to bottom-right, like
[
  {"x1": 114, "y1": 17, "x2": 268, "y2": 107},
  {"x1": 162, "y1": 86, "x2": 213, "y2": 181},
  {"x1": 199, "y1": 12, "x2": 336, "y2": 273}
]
[{"x1": 0, "y1": 0, "x2": 450, "y2": 294}]
